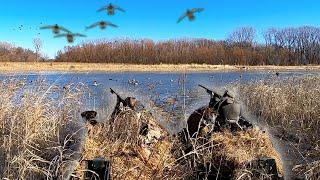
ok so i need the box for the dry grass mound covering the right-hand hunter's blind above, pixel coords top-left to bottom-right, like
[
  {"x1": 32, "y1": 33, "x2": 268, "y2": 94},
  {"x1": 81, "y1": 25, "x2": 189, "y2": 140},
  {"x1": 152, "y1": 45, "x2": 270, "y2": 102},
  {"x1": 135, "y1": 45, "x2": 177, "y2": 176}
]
[{"x1": 175, "y1": 128, "x2": 284, "y2": 179}]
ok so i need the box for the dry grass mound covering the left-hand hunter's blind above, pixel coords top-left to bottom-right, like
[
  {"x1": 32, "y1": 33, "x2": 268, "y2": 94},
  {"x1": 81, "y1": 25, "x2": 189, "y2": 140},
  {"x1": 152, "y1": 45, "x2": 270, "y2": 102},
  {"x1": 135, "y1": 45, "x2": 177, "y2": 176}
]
[{"x1": 78, "y1": 110, "x2": 182, "y2": 179}]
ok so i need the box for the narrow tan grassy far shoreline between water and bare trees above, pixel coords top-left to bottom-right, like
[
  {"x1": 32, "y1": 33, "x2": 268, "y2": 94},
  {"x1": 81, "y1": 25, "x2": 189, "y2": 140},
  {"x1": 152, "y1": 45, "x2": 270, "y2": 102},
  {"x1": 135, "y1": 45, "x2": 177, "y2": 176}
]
[{"x1": 0, "y1": 62, "x2": 320, "y2": 73}]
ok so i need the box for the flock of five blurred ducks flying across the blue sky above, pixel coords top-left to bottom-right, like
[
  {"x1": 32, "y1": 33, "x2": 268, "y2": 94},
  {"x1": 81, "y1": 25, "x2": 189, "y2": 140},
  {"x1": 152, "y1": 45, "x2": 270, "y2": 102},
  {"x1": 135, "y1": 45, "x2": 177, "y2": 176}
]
[{"x1": 40, "y1": 3, "x2": 204, "y2": 43}]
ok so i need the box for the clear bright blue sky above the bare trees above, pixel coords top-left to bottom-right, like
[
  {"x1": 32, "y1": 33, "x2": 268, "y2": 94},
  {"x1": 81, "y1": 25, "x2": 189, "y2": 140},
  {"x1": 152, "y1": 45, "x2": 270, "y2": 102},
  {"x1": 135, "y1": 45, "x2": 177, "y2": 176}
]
[{"x1": 0, "y1": 0, "x2": 320, "y2": 57}]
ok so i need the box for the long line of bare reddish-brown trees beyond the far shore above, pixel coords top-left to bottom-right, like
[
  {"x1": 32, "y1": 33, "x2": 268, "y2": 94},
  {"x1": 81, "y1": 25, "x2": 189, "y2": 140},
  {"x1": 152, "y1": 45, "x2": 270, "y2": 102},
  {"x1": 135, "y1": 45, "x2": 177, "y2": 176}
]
[{"x1": 56, "y1": 27, "x2": 320, "y2": 65}]
